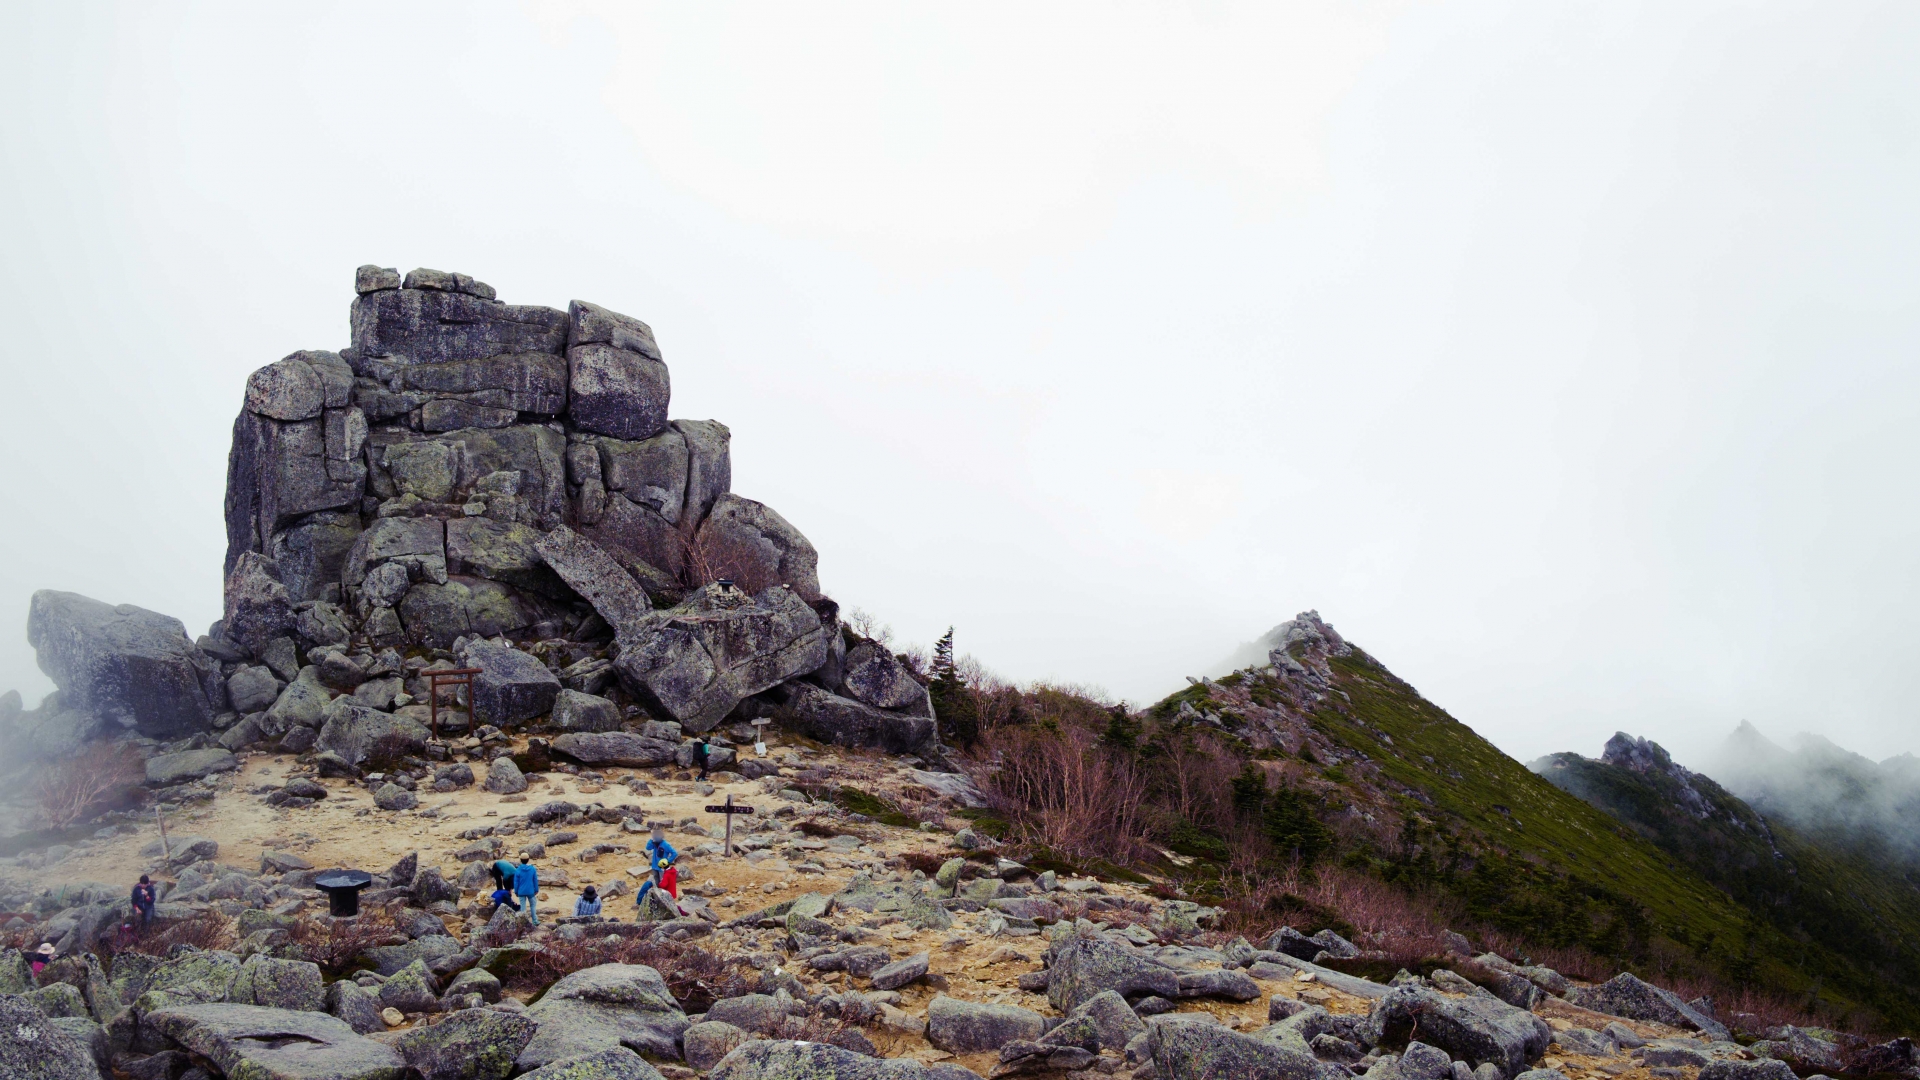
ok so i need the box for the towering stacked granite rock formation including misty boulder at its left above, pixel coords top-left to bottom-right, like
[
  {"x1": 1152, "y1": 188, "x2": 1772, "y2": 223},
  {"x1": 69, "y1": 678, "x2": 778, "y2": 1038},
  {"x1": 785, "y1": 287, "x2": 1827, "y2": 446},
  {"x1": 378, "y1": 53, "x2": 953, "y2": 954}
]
[{"x1": 0, "y1": 265, "x2": 937, "y2": 765}]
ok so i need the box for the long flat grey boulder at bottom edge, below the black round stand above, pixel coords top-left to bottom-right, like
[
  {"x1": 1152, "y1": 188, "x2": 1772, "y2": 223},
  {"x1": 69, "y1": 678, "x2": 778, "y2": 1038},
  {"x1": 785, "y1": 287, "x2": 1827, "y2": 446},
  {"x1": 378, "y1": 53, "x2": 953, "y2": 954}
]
[{"x1": 142, "y1": 1003, "x2": 407, "y2": 1080}]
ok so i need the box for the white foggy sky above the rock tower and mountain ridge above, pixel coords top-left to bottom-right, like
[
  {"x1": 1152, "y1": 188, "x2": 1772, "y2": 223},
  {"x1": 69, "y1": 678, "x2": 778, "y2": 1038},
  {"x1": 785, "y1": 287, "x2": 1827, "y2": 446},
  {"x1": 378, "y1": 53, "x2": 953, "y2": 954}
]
[{"x1": 0, "y1": 0, "x2": 1920, "y2": 759}]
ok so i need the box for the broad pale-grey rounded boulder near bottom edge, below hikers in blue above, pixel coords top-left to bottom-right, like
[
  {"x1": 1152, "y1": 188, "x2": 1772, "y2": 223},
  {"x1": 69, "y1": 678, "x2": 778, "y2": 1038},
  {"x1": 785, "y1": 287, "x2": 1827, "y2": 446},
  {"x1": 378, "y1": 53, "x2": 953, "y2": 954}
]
[{"x1": 518, "y1": 965, "x2": 687, "y2": 1068}]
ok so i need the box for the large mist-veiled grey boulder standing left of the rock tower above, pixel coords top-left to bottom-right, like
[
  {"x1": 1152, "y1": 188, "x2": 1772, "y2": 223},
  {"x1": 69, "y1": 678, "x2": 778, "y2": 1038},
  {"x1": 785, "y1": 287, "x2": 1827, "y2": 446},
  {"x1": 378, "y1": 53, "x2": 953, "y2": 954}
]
[{"x1": 27, "y1": 590, "x2": 225, "y2": 740}]
